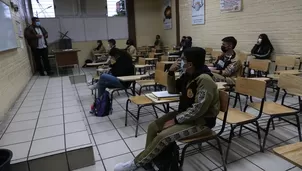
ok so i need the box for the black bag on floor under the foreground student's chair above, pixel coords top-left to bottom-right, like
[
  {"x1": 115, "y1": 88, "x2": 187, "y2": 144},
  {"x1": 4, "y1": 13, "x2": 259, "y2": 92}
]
[{"x1": 147, "y1": 142, "x2": 181, "y2": 171}]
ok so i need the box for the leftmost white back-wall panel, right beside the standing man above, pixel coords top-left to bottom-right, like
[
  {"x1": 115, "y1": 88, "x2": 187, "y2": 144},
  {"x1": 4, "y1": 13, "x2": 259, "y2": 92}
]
[{"x1": 40, "y1": 18, "x2": 60, "y2": 43}]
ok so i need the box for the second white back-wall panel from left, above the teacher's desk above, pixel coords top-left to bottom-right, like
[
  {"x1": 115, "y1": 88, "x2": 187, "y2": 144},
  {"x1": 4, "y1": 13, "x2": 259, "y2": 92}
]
[{"x1": 60, "y1": 18, "x2": 86, "y2": 41}]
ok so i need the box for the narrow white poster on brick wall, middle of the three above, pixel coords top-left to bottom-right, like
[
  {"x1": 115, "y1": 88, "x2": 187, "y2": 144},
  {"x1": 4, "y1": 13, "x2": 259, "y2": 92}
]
[{"x1": 192, "y1": 0, "x2": 205, "y2": 25}]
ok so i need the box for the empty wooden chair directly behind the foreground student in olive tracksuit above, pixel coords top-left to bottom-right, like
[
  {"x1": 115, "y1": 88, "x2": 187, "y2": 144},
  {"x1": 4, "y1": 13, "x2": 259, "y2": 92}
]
[{"x1": 218, "y1": 77, "x2": 266, "y2": 161}]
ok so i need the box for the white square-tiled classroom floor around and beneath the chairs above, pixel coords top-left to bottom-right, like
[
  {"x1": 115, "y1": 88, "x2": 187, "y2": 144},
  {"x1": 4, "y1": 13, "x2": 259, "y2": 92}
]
[{"x1": 0, "y1": 68, "x2": 300, "y2": 171}]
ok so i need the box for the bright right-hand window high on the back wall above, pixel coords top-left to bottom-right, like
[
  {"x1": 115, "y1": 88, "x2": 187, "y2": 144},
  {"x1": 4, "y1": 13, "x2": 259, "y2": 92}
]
[{"x1": 107, "y1": 0, "x2": 126, "y2": 17}]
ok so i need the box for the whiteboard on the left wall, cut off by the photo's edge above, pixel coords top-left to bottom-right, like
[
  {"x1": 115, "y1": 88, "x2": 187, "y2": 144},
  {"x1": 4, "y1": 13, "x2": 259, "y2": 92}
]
[{"x1": 0, "y1": 1, "x2": 18, "y2": 51}]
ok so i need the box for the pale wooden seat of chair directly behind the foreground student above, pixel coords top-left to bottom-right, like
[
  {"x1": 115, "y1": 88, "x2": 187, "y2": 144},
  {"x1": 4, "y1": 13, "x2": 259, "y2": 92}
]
[{"x1": 217, "y1": 108, "x2": 256, "y2": 124}]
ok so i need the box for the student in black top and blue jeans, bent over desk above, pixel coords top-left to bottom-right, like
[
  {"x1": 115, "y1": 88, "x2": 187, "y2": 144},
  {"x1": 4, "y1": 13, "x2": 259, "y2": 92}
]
[{"x1": 89, "y1": 48, "x2": 134, "y2": 97}]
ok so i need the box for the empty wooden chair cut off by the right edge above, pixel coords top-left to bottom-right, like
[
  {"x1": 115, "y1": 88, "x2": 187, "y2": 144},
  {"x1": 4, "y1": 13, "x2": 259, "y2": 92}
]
[{"x1": 250, "y1": 74, "x2": 302, "y2": 148}]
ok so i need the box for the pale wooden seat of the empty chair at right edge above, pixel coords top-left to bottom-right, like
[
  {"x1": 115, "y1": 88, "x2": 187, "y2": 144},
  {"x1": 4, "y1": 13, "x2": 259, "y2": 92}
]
[{"x1": 249, "y1": 102, "x2": 298, "y2": 115}]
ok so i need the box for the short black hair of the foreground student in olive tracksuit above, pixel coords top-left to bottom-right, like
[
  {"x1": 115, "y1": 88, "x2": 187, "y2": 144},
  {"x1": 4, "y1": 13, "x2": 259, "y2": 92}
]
[{"x1": 184, "y1": 47, "x2": 206, "y2": 68}]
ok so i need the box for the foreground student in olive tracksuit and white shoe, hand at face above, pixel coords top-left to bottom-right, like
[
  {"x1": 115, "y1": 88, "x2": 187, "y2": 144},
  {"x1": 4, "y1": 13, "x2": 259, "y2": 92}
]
[{"x1": 114, "y1": 47, "x2": 220, "y2": 171}]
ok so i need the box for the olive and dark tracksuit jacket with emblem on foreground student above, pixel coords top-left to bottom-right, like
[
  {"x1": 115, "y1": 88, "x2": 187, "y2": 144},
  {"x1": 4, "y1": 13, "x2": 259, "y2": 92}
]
[{"x1": 168, "y1": 69, "x2": 220, "y2": 128}]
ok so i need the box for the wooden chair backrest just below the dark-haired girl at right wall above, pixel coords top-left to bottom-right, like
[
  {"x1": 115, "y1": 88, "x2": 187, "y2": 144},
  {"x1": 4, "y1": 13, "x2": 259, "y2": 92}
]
[{"x1": 248, "y1": 59, "x2": 271, "y2": 77}]
